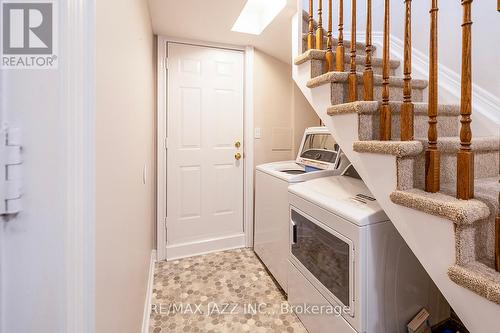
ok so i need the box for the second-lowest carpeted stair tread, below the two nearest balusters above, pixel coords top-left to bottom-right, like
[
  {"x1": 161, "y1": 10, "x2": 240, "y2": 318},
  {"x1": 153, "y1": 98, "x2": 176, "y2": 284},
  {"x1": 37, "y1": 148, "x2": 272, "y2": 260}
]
[{"x1": 391, "y1": 189, "x2": 491, "y2": 224}]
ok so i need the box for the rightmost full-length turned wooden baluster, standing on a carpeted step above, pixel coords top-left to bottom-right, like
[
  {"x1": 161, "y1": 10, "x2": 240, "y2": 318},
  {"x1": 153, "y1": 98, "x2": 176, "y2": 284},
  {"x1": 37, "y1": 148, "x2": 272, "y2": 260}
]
[{"x1": 457, "y1": 0, "x2": 474, "y2": 200}]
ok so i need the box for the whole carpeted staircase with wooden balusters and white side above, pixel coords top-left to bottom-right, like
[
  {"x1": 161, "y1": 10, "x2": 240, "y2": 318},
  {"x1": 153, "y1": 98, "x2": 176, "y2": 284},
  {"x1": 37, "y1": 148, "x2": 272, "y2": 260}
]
[{"x1": 293, "y1": 0, "x2": 500, "y2": 333}]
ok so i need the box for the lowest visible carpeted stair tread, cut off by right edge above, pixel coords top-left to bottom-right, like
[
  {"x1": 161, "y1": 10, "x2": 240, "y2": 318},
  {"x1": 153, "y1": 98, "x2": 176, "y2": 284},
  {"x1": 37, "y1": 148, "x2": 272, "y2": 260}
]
[{"x1": 448, "y1": 261, "x2": 500, "y2": 304}]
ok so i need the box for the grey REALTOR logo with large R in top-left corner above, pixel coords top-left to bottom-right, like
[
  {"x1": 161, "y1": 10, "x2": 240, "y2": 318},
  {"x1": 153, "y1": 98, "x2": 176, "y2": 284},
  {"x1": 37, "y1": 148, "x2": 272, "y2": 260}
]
[{"x1": 1, "y1": 0, "x2": 57, "y2": 69}]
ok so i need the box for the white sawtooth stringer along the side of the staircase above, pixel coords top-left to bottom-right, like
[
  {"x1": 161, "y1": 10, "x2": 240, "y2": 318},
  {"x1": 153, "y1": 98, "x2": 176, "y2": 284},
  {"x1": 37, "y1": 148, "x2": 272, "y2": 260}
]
[{"x1": 292, "y1": 11, "x2": 500, "y2": 333}]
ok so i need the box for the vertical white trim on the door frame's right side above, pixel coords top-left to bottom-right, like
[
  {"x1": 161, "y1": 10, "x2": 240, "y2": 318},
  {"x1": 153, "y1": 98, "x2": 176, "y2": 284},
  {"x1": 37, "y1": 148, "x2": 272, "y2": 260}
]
[{"x1": 243, "y1": 46, "x2": 255, "y2": 247}]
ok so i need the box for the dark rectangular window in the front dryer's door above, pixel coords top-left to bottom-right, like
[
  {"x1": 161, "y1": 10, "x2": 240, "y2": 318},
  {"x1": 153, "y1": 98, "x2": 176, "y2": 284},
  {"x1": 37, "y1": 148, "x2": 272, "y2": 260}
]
[{"x1": 291, "y1": 209, "x2": 352, "y2": 306}]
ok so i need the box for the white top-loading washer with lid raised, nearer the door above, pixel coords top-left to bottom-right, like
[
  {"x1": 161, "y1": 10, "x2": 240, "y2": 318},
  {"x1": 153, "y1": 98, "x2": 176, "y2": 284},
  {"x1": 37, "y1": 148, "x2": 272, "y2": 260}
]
[{"x1": 254, "y1": 127, "x2": 349, "y2": 292}]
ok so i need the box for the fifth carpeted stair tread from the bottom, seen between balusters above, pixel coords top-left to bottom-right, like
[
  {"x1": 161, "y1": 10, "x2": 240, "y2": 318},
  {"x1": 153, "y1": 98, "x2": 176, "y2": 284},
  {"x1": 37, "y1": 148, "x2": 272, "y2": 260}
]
[{"x1": 307, "y1": 72, "x2": 428, "y2": 89}]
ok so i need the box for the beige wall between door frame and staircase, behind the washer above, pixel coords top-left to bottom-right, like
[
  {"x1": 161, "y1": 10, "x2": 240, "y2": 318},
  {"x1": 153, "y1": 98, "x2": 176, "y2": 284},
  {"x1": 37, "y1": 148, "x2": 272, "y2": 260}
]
[{"x1": 254, "y1": 50, "x2": 319, "y2": 165}]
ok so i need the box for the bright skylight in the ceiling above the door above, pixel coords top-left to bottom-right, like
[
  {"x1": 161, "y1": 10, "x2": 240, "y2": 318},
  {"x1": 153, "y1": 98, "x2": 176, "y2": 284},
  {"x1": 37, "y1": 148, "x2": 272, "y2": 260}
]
[{"x1": 231, "y1": 0, "x2": 286, "y2": 35}]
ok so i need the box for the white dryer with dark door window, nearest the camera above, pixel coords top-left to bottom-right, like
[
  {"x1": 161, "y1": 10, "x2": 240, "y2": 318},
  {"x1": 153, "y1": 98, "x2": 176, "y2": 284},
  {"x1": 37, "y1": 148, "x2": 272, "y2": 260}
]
[{"x1": 288, "y1": 166, "x2": 450, "y2": 333}]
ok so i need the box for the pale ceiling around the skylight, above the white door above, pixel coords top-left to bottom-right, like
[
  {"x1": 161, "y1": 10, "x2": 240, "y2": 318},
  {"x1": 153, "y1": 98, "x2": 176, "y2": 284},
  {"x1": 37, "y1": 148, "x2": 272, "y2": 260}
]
[{"x1": 149, "y1": 0, "x2": 296, "y2": 63}]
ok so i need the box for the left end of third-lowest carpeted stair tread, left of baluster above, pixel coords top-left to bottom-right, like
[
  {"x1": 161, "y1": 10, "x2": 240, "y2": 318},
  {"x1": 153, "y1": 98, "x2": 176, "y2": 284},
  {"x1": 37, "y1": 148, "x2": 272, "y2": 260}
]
[{"x1": 353, "y1": 140, "x2": 424, "y2": 157}]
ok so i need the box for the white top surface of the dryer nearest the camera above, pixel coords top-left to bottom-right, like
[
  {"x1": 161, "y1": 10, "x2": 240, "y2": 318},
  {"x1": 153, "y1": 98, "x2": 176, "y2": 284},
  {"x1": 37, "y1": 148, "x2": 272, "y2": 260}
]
[{"x1": 288, "y1": 176, "x2": 389, "y2": 226}]
